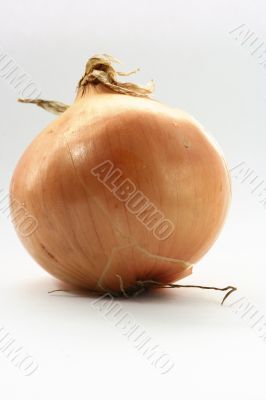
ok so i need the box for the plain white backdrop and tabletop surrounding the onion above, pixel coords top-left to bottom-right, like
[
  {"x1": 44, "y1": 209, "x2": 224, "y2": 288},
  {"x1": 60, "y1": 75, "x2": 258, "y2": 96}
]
[{"x1": 0, "y1": 0, "x2": 266, "y2": 400}]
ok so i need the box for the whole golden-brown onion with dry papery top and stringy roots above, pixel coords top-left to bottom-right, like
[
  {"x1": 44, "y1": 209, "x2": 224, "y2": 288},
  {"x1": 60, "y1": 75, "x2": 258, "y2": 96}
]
[{"x1": 10, "y1": 55, "x2": 235, "y2": 304}]
